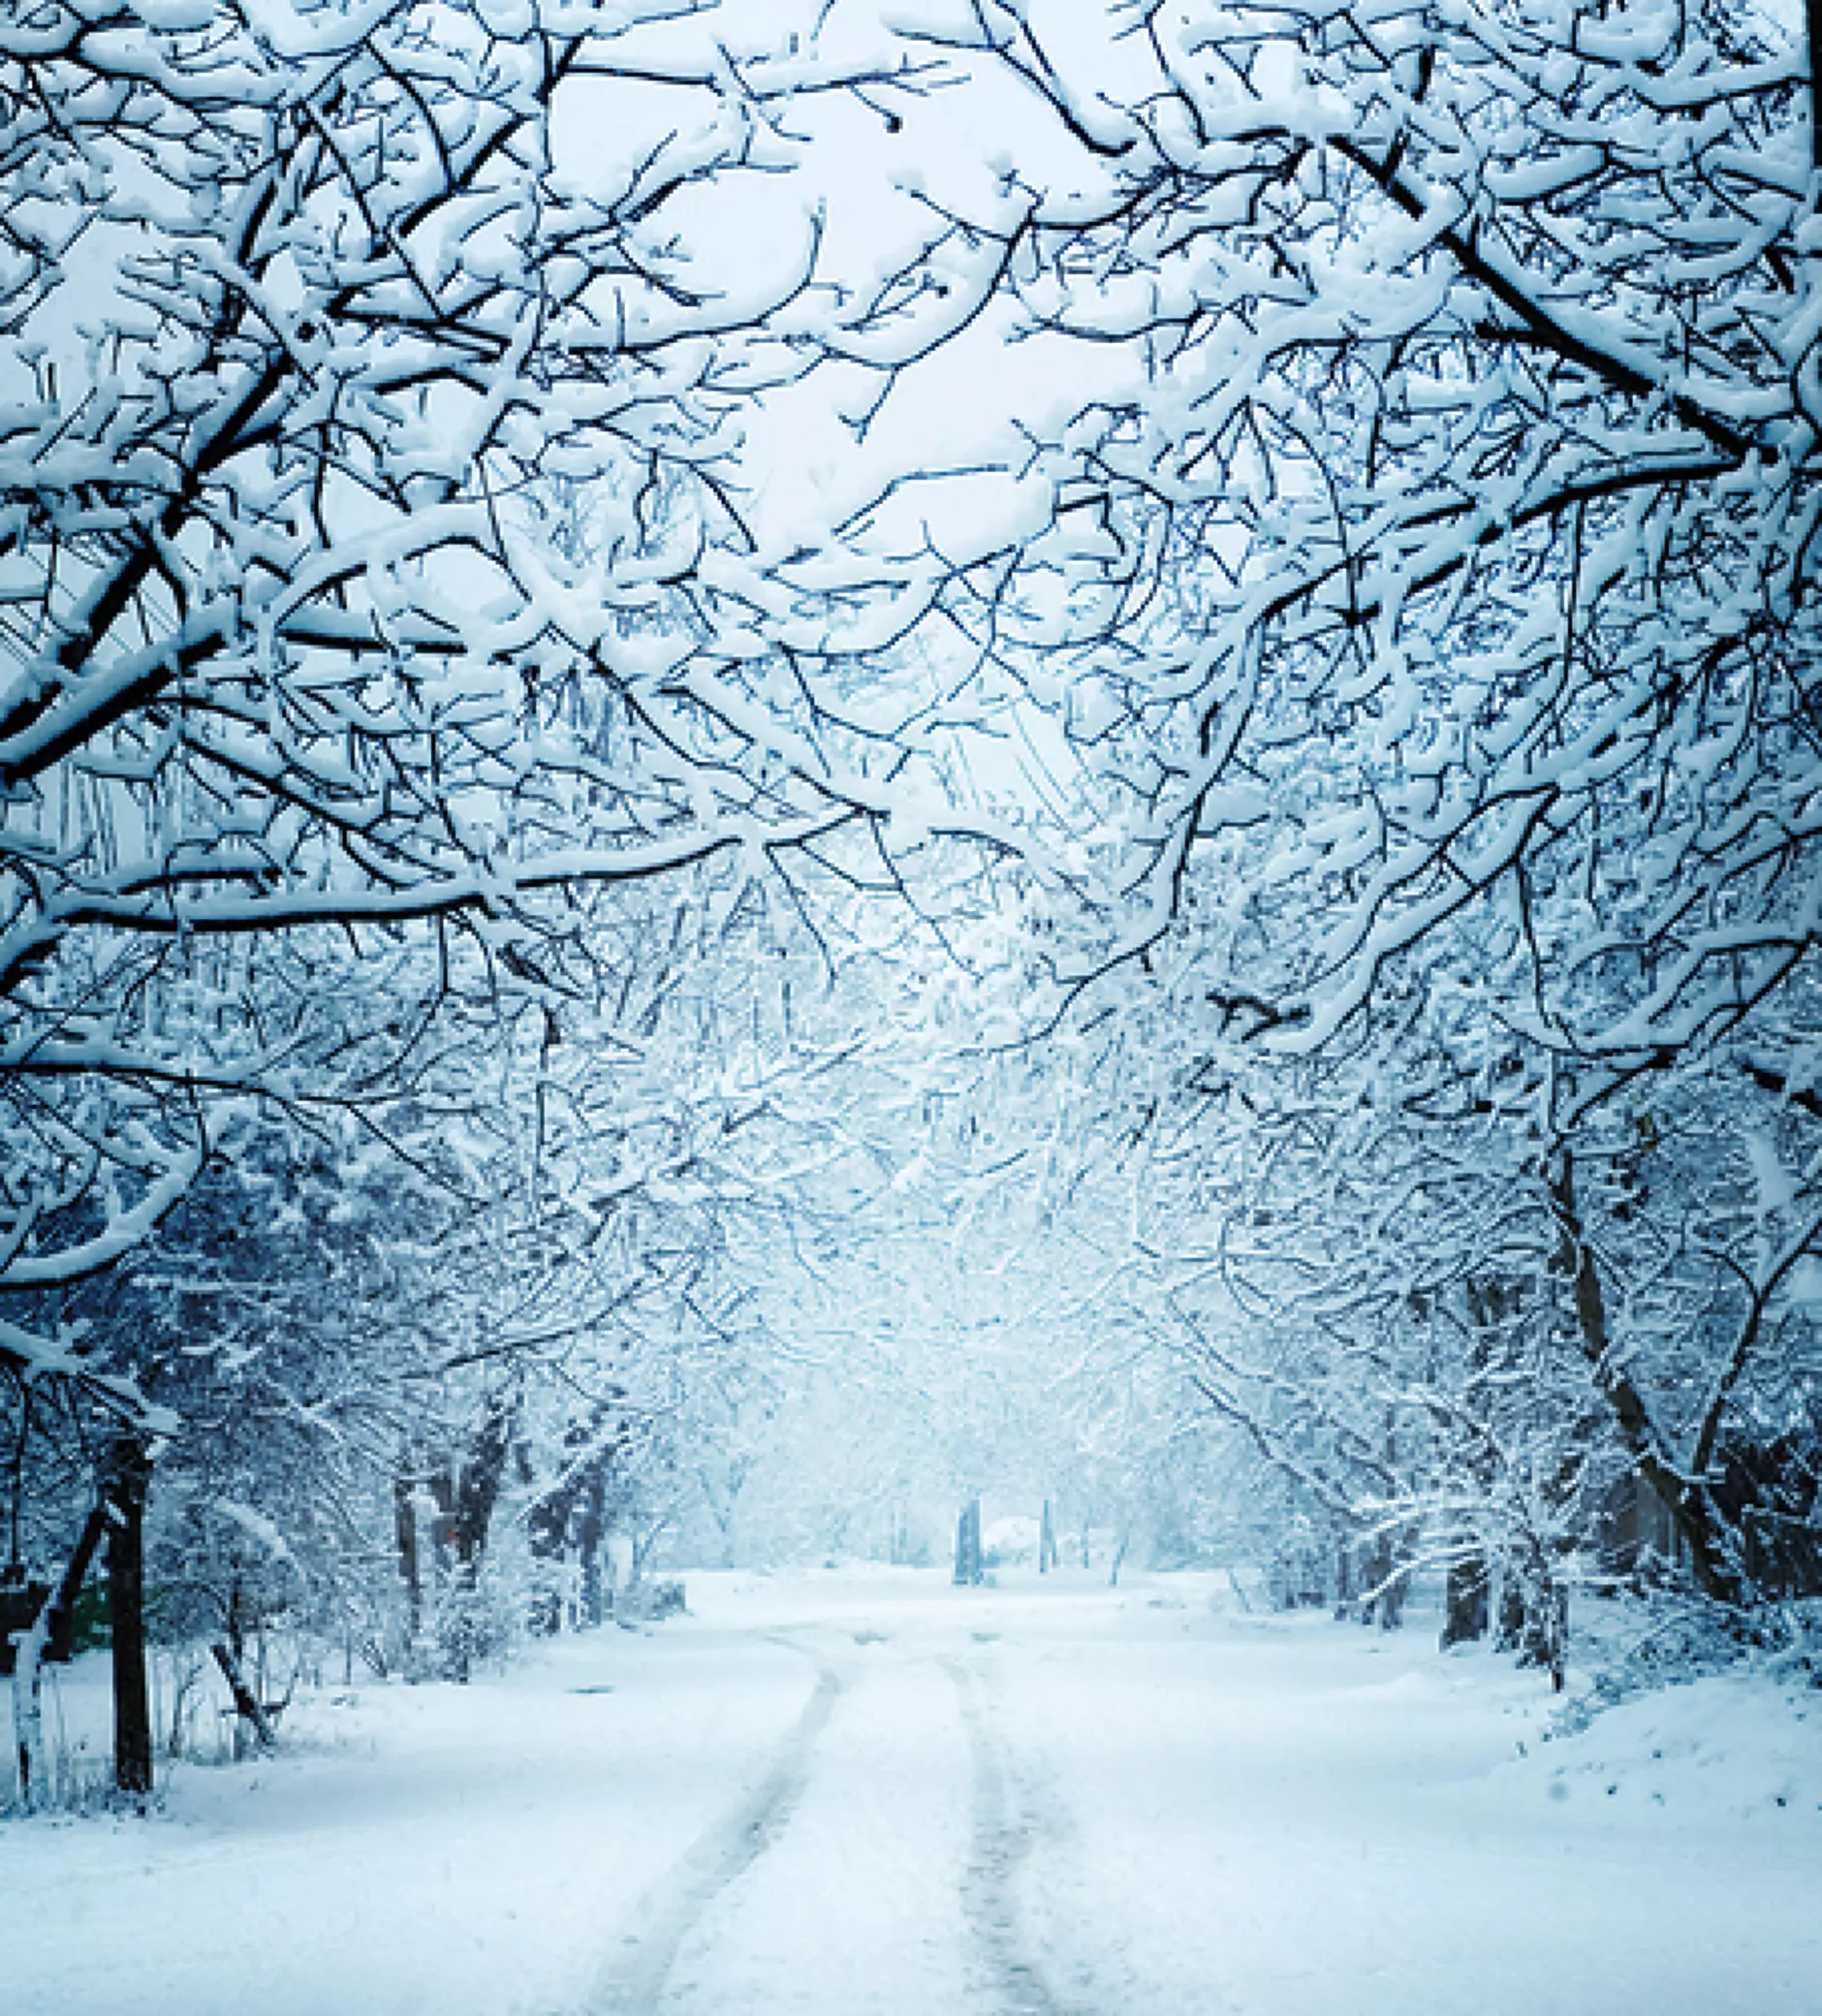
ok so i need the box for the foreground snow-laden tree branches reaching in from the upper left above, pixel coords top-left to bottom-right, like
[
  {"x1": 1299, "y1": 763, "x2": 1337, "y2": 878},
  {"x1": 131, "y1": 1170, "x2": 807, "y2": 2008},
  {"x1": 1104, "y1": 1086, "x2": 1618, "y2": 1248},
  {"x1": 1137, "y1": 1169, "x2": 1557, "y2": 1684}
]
[{"x1": 0, "y1": 0, "x2": 988, "y2": 1402}]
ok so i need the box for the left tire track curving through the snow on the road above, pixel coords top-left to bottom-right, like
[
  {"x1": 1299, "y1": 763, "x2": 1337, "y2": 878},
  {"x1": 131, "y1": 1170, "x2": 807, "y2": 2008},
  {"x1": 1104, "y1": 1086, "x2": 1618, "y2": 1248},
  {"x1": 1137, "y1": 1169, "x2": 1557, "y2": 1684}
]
[{"x1": 588, "y1": 1637, "x2": 844, "y2": 2016}]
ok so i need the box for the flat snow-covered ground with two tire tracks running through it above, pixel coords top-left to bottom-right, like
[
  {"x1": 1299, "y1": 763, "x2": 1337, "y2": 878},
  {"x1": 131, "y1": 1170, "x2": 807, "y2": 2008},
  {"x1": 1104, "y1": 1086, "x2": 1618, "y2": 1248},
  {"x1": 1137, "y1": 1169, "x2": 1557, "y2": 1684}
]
[{"x1": 0, "y1": 1570, "x2": 1822, "y2": 2016}]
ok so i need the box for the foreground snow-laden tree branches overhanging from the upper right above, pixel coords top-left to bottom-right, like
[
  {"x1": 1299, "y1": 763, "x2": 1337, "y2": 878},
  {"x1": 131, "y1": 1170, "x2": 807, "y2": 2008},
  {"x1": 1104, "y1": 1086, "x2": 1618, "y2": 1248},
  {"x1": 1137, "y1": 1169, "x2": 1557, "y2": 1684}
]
[{"x1": 854, "y1": 0, "x2": 1818, "y2": 1055}]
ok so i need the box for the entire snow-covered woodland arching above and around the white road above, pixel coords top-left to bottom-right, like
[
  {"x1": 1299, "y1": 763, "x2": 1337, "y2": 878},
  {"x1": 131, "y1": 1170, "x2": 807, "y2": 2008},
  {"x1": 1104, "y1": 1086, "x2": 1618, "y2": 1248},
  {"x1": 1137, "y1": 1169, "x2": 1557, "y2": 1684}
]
[{"x1": 0, "y1": 0, "x2": 1822, "y2": 1805}]
